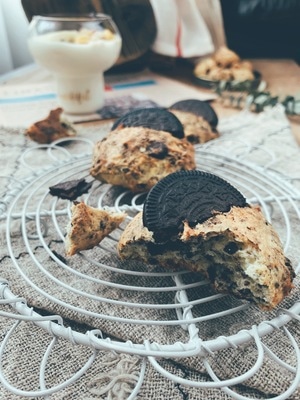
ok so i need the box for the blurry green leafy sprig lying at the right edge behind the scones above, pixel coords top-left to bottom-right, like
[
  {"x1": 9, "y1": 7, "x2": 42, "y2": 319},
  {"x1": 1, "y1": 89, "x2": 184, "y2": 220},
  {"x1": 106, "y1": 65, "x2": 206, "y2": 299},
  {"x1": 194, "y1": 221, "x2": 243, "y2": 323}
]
[{"x1": 214, "y1": 81, "x2": 300, "y2": 116}]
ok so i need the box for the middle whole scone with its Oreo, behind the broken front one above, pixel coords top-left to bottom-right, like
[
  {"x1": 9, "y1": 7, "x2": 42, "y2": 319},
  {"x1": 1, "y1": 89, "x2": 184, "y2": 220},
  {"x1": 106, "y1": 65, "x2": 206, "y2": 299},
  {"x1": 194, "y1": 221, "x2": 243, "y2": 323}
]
[{"x1": 90, "y1": 108, "x2": 196, "y2": 193}]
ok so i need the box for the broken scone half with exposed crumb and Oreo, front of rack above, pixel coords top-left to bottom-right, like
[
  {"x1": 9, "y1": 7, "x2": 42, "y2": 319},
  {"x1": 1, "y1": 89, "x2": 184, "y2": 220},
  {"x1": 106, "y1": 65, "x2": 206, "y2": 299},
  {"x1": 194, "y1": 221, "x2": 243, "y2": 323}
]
[{"x1": 118, "y1": 170, "x2": 294, "y2": 311}]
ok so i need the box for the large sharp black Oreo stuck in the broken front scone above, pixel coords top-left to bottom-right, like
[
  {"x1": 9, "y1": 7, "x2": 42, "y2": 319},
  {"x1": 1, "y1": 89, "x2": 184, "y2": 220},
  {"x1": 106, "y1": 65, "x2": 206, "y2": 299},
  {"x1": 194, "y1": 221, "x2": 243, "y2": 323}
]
[{"x1": 143, "y1": 170, "x2": 247, "y2": 243}]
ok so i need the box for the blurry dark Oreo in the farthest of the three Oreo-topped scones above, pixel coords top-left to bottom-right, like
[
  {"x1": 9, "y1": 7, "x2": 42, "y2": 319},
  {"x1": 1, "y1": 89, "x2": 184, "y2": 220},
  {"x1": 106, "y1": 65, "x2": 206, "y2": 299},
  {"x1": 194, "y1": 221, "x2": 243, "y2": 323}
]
[{"x1": 169, "y1": 99, "x2": 219, "y2": 128}]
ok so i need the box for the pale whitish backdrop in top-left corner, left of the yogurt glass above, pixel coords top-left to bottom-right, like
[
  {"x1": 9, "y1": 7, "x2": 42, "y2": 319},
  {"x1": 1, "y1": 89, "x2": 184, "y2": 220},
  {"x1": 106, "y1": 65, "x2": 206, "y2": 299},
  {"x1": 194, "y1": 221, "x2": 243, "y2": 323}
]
[{"x1": 0, "y1": 0, "x2": 33, "y2": 74}]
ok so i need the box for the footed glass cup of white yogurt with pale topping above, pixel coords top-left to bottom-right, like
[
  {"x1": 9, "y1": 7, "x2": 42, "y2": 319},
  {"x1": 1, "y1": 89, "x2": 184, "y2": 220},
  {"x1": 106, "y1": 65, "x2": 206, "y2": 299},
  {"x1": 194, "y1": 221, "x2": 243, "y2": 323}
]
[{"x1": 28, "y1": 14, "x2": 122, "y2": 114}]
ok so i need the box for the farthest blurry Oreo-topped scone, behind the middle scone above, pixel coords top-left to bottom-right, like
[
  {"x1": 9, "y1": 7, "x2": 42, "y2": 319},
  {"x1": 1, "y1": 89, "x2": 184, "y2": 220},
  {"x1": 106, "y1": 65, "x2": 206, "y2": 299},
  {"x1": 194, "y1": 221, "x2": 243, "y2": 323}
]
[{"x1": 169, "y1": 99, "x2": 220, "y2": 144}]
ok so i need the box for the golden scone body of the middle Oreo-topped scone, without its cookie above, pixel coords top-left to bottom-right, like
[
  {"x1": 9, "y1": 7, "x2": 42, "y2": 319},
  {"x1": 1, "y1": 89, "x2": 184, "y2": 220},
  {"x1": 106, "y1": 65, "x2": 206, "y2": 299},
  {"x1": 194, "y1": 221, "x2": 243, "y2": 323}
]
[{"x1": 90, "y1": 126, "x2": 196, "y2": 193}]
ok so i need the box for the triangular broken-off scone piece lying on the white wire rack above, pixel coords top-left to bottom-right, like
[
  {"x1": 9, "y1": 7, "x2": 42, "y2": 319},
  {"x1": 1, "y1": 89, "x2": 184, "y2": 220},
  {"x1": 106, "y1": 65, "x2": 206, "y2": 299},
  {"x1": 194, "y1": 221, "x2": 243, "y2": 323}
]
[{"x1": 65, "y1": 201, "x2": 126, "y2": 256}]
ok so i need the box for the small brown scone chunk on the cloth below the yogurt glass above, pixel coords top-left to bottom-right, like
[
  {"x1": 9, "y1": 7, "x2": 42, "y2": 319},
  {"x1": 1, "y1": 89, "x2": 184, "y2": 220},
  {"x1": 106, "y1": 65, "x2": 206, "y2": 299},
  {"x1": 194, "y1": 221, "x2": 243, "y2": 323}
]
[{"x1": 25, "y1": 108, "x2": 77, "y2": 144}]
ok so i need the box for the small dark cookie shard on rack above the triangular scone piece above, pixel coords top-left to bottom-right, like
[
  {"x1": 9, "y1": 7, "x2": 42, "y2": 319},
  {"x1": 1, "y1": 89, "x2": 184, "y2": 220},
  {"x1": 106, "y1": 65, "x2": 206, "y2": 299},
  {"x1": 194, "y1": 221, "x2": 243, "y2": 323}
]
[{"x1": 49, "y1": 179, "x2": 93, "y2": 201}]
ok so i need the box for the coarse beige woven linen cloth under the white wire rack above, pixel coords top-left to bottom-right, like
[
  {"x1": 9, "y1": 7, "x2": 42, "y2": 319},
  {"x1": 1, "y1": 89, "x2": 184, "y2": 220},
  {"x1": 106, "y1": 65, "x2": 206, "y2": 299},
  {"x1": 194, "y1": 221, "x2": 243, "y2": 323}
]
[{"x1": 0, "y1": 107, "x2": 300, "y2": 400}]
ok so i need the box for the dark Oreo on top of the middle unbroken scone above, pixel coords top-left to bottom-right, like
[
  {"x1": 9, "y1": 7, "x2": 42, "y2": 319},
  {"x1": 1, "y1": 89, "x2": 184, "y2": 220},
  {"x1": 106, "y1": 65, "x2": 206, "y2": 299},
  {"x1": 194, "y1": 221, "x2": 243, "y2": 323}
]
[{"x1": 111, "y1": 107, "x2": 184, "y2": 139}]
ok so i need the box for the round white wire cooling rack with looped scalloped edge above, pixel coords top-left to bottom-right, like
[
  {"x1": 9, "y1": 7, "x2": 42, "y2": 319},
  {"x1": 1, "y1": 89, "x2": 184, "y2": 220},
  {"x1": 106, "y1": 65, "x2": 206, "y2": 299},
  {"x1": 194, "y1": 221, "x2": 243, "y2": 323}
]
[{"x1": 0, "y1": 139, "x2": 300, "y2": 399}]
